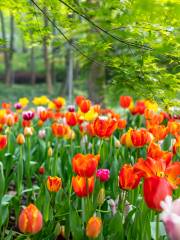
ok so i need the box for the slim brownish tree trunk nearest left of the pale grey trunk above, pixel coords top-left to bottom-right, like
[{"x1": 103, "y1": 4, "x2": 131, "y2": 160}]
[{"x1": 43, "y1": 9, "x2": 53, "y2": 94}]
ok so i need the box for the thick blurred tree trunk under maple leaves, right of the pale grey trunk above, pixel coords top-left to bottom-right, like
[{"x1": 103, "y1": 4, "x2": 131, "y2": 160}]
[{"x1": 88, "y1": 62, "x2": 105, "y2": 103}]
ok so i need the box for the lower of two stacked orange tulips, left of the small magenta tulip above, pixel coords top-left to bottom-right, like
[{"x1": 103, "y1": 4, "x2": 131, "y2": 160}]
[{"x1": 72, "y1": 176, "x2": 94, "y2": 197}]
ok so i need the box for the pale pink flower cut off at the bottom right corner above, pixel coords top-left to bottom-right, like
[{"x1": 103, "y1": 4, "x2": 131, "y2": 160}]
[{"x1": 161, "y1": 196, "x2": 180, "y2": 240}]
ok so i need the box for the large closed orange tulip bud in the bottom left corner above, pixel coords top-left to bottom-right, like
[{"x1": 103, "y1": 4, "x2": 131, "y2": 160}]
[{"x1": 18, "y1": 204, "x2": 43, "y2": 234}]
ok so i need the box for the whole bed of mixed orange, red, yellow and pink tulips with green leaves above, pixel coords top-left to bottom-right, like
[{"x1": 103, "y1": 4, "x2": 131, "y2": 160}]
[{"x1": 0, "y1": 96, "x2": 180, "y2": 240}]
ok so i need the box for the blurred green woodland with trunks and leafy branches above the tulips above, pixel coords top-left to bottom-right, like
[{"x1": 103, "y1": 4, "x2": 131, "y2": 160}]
[{"x1": 0, "y1": 0, "x2": 180, "y2": 109}]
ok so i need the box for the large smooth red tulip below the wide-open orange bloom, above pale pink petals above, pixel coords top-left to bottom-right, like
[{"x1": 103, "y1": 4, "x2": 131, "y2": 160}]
[{"x1": 143, "y1": 176, "x2": 172, "y2": 211}]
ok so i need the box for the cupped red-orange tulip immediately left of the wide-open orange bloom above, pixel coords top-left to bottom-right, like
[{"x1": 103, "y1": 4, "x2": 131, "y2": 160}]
[{"x1": 119, "y1": 164, "x2": 141, "y2": 190}]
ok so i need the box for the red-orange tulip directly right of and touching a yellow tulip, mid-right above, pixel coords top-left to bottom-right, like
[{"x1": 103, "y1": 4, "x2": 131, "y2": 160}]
[{"x1": 130, "y1": 129, "x2": 150, "y2": 147}]
